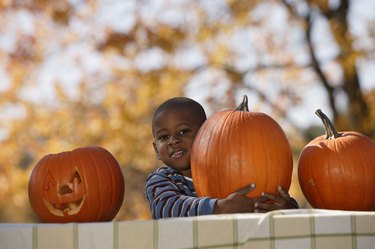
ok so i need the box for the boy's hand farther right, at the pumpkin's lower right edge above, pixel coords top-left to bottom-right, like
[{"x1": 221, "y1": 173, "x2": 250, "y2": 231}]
[{"x1": 254, "y1": 186, "x2": 297, "y2": 212}]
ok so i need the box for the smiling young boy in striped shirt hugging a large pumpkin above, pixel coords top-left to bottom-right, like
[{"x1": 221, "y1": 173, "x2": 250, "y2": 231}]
[{"x1": 145, "y1": 97, "x2": 298, "y2": 219}]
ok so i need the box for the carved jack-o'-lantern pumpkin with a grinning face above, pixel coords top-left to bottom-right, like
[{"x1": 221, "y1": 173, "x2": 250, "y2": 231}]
[{"x1": 28, "y1": 146, "x2": 125, "y2": 223}]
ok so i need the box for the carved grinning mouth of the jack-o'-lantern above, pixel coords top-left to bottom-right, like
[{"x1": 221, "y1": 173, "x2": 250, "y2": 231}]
[{"x1": 43, "y1": 194, "x2": 87, "y2": 216}]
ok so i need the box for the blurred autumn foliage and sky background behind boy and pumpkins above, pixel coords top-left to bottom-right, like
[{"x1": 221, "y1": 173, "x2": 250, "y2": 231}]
[{"x1": 0, "y1": 0, "x2": 375, "y2": 222}]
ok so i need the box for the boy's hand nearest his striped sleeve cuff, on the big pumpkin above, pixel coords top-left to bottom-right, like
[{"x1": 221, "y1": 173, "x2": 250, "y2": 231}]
[{"x1": 214, "y1": 183, "x2": 269, "y2": 214}]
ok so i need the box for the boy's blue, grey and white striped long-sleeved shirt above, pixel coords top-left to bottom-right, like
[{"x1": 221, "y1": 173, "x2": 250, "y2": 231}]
[{"x1": 145, "y1": 166, "x2": 217, "y2": 219}]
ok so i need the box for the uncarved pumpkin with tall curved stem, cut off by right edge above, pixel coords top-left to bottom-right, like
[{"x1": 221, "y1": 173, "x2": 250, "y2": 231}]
[{"x1": 298, "y1": 109, "x2": 375, "y2": 211}]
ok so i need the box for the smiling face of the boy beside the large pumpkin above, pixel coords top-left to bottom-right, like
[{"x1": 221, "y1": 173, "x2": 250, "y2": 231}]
[{"x1": 153, "y1": 108, "x2": 201, "y2": 177}]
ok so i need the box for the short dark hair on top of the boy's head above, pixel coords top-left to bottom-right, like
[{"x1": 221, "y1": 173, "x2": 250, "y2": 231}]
[{"x1": 152, "y1": 97, "x2": 207, "y2": 131}]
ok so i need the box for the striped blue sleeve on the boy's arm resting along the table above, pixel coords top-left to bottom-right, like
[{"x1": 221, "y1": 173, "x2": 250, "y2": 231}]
[{"x1": 145, "y1": 171, "x2": 217, "y2": 219}]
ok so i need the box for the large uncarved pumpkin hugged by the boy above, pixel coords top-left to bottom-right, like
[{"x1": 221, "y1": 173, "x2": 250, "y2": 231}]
[{"x1": 191, "y1": 95, "x2": 293, "y2": 198}]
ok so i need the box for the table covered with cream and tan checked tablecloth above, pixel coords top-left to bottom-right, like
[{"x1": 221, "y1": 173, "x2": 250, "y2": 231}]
[{"x1": 0, "y1": 209, "x2": 375, "y2": 249}]
